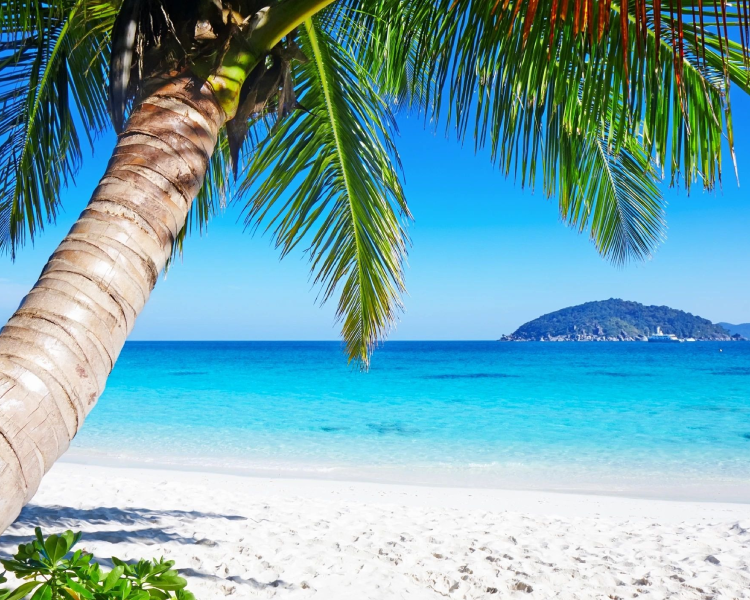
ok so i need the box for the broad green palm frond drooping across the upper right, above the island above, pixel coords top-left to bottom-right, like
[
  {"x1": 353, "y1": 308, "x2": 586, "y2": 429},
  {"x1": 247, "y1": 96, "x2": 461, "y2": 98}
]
[{"x1": 351, "y1": 0, "x2": 749, "y2": 188}]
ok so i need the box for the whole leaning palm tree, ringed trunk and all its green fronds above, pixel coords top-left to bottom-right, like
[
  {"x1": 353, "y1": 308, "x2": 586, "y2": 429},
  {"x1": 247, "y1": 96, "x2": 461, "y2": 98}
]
[{"x1": 0, "y1": 0, "x2": 750, "y2": 531}]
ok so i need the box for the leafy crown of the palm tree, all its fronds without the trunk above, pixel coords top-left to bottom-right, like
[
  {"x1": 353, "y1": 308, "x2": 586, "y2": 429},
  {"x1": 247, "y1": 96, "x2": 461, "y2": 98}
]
[{"x1": 0, "y1": 0, "x2": 750, "y2": 366}]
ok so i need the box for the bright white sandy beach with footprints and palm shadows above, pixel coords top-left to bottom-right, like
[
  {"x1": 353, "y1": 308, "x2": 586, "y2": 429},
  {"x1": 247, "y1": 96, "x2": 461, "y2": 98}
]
[{"x1": 0, "y1": 463, "x2": 750, "y2": 600}]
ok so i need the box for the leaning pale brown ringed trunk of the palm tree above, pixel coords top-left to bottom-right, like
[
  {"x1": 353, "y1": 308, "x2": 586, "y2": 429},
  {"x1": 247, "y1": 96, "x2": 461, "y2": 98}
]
[{"x1": 0, "y1": 75, "x2": 226, "y2": 533}]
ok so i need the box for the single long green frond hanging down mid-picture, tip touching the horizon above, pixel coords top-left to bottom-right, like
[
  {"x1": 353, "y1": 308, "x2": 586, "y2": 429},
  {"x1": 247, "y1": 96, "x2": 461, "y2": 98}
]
[{"x1": 241, "y1": 18, "x2": 409, "y2": 368}]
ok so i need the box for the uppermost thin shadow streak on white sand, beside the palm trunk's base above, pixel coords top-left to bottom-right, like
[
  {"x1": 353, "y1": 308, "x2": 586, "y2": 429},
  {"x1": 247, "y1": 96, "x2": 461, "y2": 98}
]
[{"x1": 8, "y1": 504, "x2": 247, "y2": 528}]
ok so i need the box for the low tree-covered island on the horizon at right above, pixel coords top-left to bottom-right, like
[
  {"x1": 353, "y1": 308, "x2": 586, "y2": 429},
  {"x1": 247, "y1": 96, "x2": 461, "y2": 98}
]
[{"x1": 500, "y1": 298, "x2": 744, "y2": 342}]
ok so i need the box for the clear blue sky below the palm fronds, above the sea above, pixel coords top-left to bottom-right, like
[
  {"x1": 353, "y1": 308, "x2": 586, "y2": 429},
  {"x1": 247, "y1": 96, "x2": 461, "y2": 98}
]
[{"x1": 0, "y1": 95, "x2": 750, "y2": 340}]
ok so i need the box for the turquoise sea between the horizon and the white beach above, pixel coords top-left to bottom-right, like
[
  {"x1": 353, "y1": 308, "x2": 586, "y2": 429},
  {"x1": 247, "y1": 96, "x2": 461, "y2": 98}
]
[{"x1": 70, "y1": 342, "x2": 750, "y2": 502}]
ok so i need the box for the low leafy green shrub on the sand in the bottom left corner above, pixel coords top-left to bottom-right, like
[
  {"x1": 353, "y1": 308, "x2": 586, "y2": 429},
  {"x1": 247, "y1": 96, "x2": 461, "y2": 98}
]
[{"x1": 0, "y1": 527, "x2": 195, "y2": 600}]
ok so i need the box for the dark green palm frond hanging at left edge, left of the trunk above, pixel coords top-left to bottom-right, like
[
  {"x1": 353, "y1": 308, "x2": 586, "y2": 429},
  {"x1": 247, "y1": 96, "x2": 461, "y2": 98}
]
[{"x1": 0, "y1": 0, "x2": 116, "y2": 253}]
